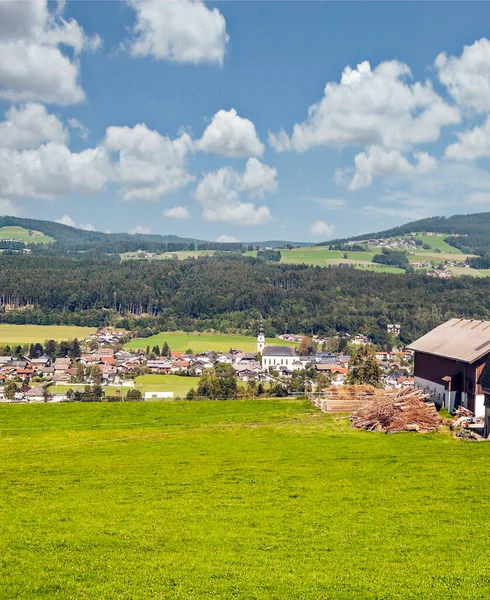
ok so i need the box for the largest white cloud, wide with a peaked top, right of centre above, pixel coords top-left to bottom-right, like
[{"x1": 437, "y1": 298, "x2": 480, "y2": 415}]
[{"x1": 269, "y1": 60, "x2": 460, "y2": 152}]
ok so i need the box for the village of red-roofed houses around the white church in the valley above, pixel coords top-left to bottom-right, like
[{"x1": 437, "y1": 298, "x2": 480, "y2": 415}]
[{"x1": 0, "y1": 325, "x2": 414, "y2": 403}]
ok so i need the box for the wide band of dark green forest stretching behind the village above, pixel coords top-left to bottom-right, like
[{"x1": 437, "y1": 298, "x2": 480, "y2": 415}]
[{"x1": 0, "y1": 255, "x2": 490, "y2": 343}]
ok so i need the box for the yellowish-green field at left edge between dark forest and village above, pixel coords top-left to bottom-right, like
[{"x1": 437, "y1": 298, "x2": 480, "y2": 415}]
[{"x1": 0, "y1": 323, "x2": 97, "y2": 346}]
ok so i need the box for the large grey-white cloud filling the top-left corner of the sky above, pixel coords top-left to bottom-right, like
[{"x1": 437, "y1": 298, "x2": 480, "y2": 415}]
[{"x1": 0, "y1": 0, "x2": 100, "y2": 105}]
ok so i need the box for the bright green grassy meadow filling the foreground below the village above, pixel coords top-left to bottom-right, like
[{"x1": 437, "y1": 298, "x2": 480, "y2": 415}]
[{"x1": 0, "y1": 400, "x2": 490, "y2": 600}]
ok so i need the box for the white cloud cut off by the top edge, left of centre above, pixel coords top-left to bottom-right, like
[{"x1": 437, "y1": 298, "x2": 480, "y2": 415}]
[{"x1": 128, "y1": 0, "x2": 229, "y2": 65}]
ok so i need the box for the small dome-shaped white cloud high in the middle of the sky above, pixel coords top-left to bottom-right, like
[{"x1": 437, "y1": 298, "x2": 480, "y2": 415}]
[{"x1": 197, "y1": 108, "x2": 264, "y2": 157}]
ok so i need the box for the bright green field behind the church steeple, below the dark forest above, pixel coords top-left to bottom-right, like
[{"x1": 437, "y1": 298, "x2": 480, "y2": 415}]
[{"x1": 126, "y1": 331, "x2": 294, "y2": 353}]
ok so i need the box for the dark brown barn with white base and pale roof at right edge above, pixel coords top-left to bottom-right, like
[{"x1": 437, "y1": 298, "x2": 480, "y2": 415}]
[{"x1": 408, "y1": 319, "x2": 490, "y2": 417}]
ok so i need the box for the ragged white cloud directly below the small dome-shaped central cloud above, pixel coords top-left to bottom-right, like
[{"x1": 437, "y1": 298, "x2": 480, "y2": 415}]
[{"x1": 196, "y1": 159, "x2": 275, "y2": 226}]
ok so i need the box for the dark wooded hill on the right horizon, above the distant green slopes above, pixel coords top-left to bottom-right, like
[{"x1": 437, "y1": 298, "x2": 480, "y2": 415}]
[{"x1": 318, "y1": 212, "x2": 490, "y2": 256}]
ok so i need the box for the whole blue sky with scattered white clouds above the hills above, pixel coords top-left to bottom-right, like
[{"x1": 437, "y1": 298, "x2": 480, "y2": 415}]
[{"x1": 0, "y1": 0, "x2": 490, "y2": 242}]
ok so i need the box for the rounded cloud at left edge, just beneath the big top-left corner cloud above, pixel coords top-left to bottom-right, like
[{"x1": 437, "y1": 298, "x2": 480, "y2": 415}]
[{"x1": 0, "y1": 103, "x2": 67, "y2": 150}]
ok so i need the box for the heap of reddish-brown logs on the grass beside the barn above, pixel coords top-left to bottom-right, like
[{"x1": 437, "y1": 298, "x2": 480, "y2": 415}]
[{"x1": 351, "y1": 389, "x2": 444, "y2": 433}]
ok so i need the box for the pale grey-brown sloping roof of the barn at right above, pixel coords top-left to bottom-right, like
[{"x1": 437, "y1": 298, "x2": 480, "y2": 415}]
[{"x1": 408, "y1": 319, "x2": 490, "y2": 363}]
